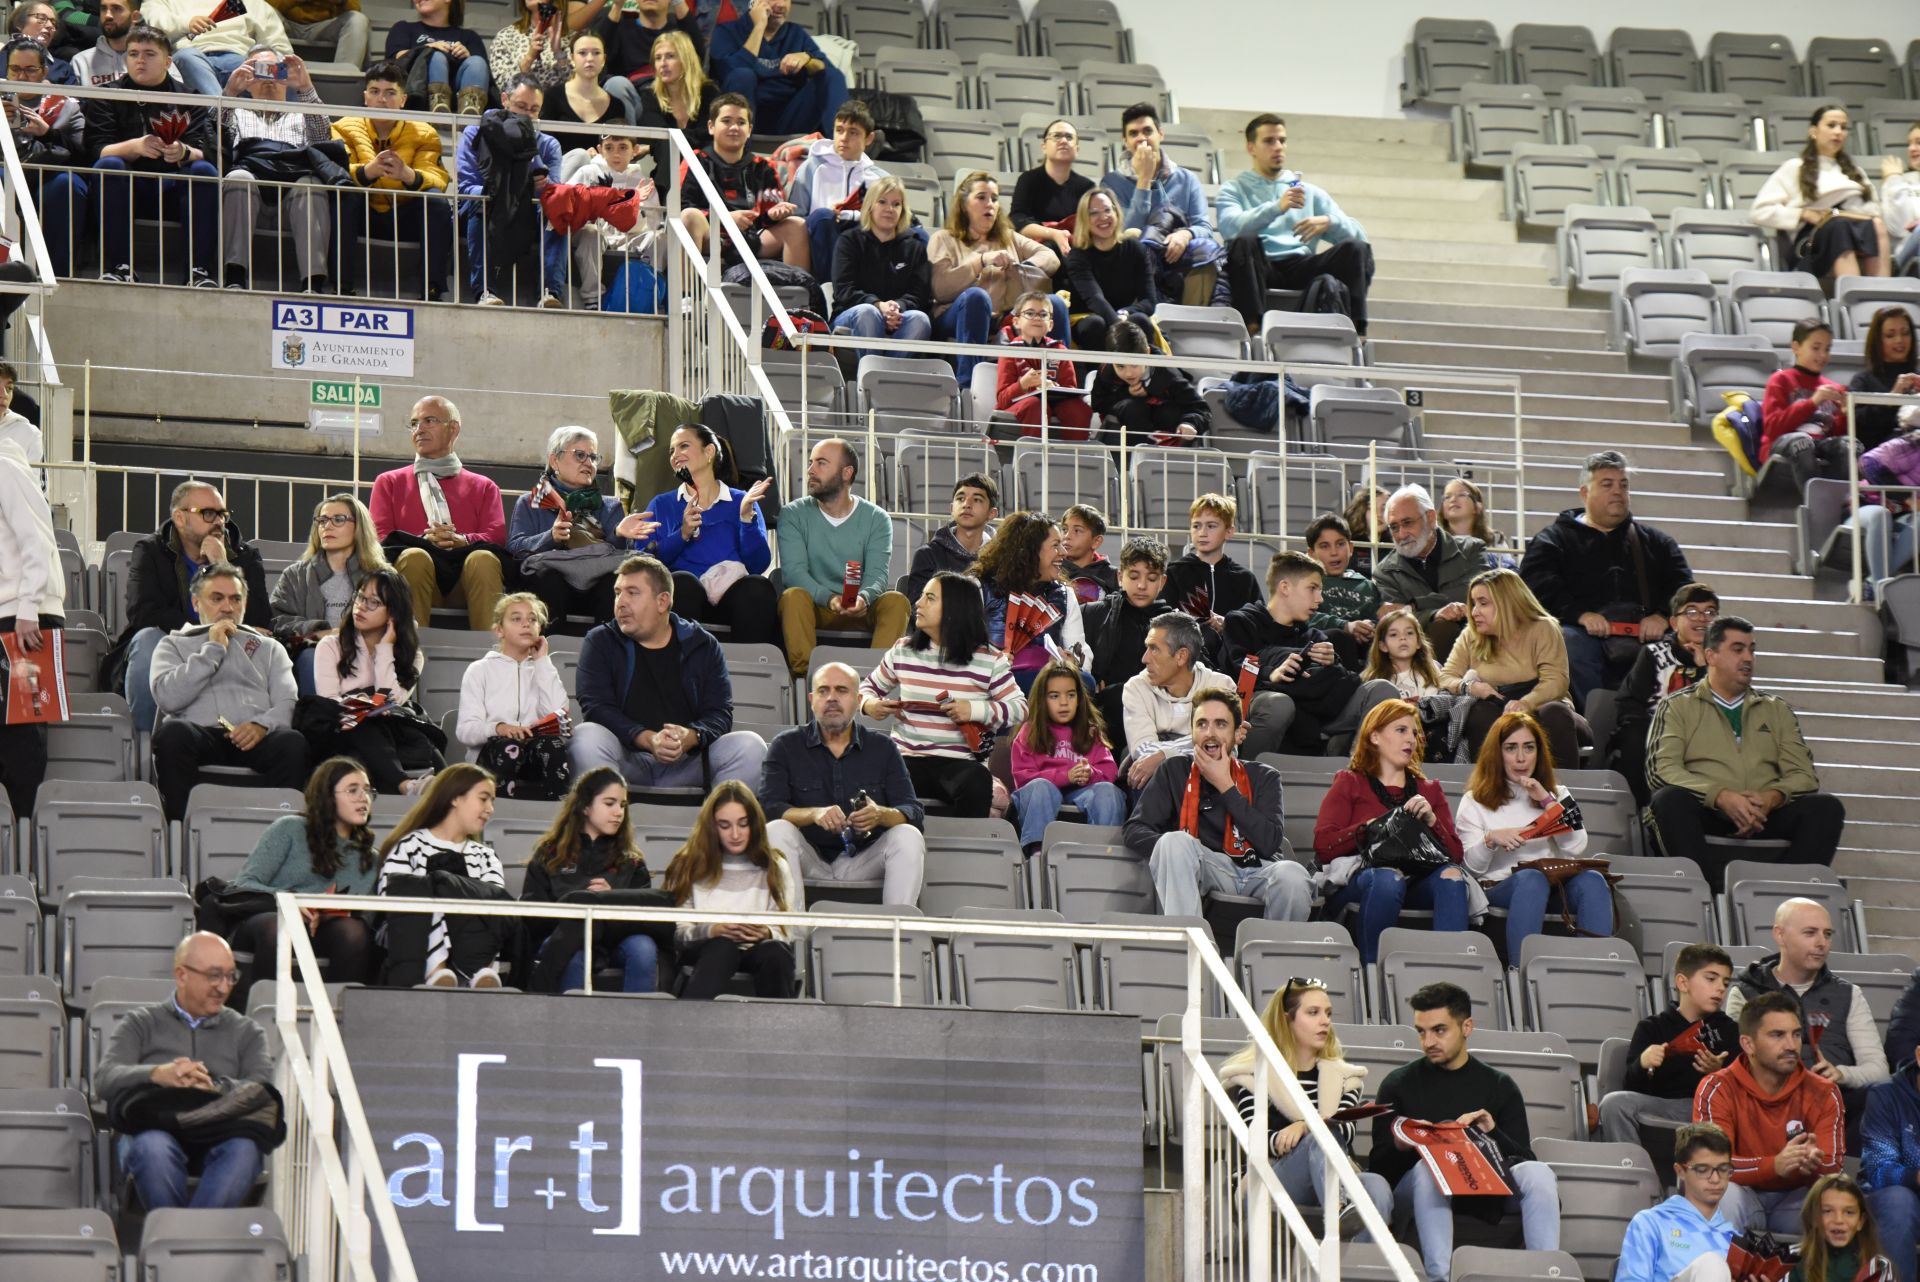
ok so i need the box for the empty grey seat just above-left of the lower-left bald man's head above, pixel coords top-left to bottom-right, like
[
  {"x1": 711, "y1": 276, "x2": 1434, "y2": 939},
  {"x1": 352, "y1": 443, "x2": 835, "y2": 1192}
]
[{"x1": 54, "y1": 877, "x2": 194, "y2": 1009}]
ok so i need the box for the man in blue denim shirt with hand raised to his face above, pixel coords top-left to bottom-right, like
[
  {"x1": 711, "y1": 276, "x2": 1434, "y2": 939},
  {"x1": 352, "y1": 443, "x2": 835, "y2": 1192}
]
[{"x1": 1104, "y1": 102, "x2": 1225, "y2": 307}]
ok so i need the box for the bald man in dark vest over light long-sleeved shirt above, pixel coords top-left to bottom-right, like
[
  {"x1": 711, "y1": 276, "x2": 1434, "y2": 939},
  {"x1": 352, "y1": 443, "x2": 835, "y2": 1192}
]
[{"x1": 1726, "y1": 898, "x2": 1889, "y2": 1151}]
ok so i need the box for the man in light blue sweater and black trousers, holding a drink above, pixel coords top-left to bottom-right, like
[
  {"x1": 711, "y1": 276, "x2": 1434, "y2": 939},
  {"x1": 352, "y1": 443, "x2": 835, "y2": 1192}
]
[{"x1": 1215, "y1": 115, "x2": 1373, "y2": 334}]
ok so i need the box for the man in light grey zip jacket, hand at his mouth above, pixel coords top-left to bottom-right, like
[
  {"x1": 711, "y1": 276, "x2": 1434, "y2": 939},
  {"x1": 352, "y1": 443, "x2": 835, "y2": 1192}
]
[{"x1": 154, "y1": 562, "x2": 307, "y2": 819}]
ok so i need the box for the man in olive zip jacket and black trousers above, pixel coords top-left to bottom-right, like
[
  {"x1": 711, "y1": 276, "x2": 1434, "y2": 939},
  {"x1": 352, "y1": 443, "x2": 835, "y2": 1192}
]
[{"x1": 1647, "y1": 614, "x2": 1847, "y2": 890}]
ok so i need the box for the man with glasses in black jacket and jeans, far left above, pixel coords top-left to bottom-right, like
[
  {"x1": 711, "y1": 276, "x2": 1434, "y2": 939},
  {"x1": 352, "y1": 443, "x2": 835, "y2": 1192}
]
[{"x1": 108, "y1": 482, "x2": 273, "y2": 731}]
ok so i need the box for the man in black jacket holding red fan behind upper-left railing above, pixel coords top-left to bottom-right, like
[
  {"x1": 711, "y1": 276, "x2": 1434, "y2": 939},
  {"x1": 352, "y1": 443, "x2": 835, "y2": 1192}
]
[{"x1": 84, "y1": 27, "x2": 221, "y2": 288}]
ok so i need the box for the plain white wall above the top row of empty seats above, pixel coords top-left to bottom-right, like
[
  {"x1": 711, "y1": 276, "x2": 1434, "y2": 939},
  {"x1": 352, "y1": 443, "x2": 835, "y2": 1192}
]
[{"x1": 1116, "y1": 0, "x2": 1920, "y2": 115}]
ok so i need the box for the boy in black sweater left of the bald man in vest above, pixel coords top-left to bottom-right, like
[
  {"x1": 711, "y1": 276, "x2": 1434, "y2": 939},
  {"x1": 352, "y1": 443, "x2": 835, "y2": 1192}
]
[{"x1": 1599, "y1": 944, "x2": 1740, "y2": 1144}]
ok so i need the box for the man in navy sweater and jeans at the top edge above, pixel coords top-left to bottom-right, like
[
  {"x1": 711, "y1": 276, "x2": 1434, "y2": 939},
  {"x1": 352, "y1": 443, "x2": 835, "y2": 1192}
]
[{"x1": 708, "y1": 0, "x2": 847, "y2": 139}]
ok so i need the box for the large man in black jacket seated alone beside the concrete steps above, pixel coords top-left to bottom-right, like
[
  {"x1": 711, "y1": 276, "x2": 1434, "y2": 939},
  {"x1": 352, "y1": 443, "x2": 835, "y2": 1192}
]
[{"x1": 1521, "y1": 449, "x2": 1693, "y2": 708}]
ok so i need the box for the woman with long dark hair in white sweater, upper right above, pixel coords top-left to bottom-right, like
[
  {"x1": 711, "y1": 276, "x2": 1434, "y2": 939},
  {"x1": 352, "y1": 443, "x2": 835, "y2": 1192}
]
[{"x1": 1751, "y1": 106, "x2": 1887, "y2": 280}]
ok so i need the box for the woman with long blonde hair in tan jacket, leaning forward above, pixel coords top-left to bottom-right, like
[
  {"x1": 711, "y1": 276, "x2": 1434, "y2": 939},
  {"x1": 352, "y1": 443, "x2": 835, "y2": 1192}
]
[{"x1": 1440, "y1": 570, "x2": 1580, "y2": 764}]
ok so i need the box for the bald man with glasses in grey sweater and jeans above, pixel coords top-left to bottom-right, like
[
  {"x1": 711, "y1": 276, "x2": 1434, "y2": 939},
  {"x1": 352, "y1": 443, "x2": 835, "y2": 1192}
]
[{"x1": 94, "y1": 931, "x2": 273, "y2": 1211}]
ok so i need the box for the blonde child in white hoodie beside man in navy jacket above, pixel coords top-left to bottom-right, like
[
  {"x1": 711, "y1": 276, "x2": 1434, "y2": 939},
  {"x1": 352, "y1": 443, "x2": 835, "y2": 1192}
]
[{"x1": 453, "y1": 591, "x2": 572, "y2": 798}]
